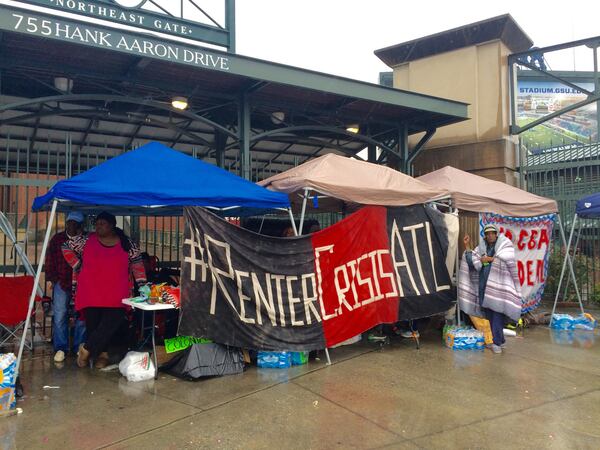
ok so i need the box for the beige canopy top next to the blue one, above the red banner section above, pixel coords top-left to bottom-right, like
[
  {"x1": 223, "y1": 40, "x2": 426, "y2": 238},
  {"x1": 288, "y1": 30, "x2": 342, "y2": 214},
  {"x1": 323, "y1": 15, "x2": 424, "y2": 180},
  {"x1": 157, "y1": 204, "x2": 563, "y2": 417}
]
[{"x1": 259, "y1": 154, "x2": 449, "y2": 210}]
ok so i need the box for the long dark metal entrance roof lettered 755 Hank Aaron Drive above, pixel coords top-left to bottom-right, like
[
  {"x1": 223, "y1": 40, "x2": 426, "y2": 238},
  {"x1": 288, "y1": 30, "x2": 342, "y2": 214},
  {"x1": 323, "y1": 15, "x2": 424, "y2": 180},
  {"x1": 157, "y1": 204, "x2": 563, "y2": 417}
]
[{"x1": 0, "y1": 5, "x2": 468, "y2": 179}]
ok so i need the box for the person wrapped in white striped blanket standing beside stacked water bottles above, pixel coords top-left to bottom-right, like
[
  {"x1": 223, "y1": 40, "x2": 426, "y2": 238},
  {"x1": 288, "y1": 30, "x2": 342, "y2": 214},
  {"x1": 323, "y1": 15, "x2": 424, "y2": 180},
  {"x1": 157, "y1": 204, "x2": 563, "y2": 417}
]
[{"x1": 463, "y1": 224, "x2": 520, "y2": 353}]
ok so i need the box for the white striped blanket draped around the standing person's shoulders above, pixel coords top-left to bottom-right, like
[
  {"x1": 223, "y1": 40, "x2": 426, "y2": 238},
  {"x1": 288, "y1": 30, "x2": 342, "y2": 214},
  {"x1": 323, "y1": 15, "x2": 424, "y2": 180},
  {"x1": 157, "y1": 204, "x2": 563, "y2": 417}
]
[{"x1": 458, "y1": 234, "x2": 522, "y2": 321}]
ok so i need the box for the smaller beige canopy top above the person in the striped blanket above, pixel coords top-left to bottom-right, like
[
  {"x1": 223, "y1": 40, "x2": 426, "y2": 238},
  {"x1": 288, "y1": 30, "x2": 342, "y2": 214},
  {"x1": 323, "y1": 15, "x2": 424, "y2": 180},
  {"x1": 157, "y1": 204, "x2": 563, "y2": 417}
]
[{"x1": 417, "y1": 166, "x2": 558, "y2": 217}]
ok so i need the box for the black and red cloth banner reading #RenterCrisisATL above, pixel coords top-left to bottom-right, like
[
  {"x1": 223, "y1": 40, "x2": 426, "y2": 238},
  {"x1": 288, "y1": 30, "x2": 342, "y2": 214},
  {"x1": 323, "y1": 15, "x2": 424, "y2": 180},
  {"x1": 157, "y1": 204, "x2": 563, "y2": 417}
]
[{"x1": 179, "y1": 205, "x2": 454, "y2": 350}]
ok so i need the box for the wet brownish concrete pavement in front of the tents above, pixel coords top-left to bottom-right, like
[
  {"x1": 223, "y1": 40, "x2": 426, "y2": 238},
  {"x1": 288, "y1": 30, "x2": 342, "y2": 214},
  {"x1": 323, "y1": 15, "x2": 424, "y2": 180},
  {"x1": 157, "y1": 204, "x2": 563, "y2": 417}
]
[{"x1": 0, "y1": 326, "x2": 600, "y2": 449}]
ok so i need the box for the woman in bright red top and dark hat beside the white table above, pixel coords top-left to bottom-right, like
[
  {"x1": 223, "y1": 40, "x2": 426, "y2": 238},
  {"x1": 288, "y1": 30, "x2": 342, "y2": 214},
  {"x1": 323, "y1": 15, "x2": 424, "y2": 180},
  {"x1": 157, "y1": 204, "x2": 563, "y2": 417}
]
[{"x1": 63, "y1": 212, "x2": 146, "y2": 369}]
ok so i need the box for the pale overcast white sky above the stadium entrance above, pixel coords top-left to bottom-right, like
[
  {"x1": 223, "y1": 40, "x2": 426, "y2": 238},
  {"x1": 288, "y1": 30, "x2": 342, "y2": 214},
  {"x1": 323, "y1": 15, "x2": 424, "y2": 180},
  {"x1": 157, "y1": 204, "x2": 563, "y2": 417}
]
[{"x1": 236, "y1": 0, "x2": 600, "y2": 83}]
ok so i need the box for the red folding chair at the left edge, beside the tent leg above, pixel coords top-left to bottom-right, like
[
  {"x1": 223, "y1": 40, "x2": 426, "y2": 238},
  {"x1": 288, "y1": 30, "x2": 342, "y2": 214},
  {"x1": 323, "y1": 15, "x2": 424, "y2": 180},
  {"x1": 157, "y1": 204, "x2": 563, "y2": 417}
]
[{"x1": 0, "y1": 275, "x2": 41, "y2": 350}]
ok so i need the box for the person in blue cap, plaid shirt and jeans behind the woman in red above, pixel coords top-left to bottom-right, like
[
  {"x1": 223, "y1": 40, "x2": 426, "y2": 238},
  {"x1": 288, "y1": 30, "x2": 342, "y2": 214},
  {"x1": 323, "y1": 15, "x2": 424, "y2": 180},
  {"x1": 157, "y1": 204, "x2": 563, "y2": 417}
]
[{"x1": 44, "y1": 211, "x2": 85, "y2": 363}]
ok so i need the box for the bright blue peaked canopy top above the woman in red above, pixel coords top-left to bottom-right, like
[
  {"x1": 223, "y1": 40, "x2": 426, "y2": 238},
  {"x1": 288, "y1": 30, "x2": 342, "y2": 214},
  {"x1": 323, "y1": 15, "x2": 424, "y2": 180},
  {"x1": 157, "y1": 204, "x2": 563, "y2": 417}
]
[{"x1": 32, "y1": 142, "x2": 289, "y2": 216}]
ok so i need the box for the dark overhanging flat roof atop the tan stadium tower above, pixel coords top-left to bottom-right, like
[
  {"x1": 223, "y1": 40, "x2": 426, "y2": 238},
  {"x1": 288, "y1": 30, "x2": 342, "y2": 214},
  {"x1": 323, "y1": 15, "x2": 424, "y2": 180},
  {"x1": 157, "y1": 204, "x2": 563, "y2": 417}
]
[{"x1": 375, "y1": 14, "x2": 533, "y2": 67}]
